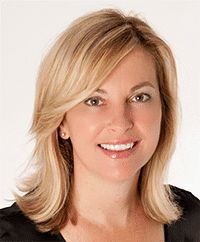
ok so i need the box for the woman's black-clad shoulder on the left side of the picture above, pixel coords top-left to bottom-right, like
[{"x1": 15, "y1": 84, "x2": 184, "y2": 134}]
[{"x1": 0, "y1": 203, "x2": 59, "y2": 242}]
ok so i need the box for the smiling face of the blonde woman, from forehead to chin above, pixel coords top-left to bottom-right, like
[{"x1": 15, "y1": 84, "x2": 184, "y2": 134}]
[{"x1": 61, "y1": 48, "x2": 162, "y2": 181}]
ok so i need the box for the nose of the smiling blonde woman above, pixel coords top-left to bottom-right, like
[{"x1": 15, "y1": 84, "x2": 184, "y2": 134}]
[{"x1": 107, "y1": 107, "x2": 134, "y2": 134}]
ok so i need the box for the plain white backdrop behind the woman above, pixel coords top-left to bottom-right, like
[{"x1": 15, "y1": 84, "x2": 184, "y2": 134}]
[{"x1": 0, "y1": 0, "x2": 200, "y2": 207}]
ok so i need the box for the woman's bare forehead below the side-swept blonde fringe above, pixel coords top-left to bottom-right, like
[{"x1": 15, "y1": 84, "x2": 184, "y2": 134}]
[{"x1": 97, "y1": 48, "x2": 157, "y2": 92}]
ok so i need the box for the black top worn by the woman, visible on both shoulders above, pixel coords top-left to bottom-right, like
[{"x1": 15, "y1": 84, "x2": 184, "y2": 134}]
[{"x1": 0, "y1": 186, "x2": 200, "y2": 242}]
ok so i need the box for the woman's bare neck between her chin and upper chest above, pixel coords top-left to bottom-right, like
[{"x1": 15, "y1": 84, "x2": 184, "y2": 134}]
[{"x1": 69, "y1": 162, "x2": 140, "y2": 227}]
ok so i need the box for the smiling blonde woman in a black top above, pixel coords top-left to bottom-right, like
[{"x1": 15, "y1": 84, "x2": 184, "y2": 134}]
[{"x1": 0, "y1": 9, "x2": 200, "y2": 242}]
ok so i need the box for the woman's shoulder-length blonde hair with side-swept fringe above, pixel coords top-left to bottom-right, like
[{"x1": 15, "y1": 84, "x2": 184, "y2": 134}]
[{"x1": 15, "y1": 9, "x2": 181, "y2": 233}]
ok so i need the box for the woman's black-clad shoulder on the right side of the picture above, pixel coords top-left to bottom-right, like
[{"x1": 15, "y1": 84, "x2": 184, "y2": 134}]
[{"x1": 168, "y1": 185, "x2": 200, "y2": 242}]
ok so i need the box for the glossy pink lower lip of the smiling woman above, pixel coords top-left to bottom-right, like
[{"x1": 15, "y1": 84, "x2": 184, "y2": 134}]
[{"x1": 98, "y1": 142, "x2": 138, "y2": 159}]
